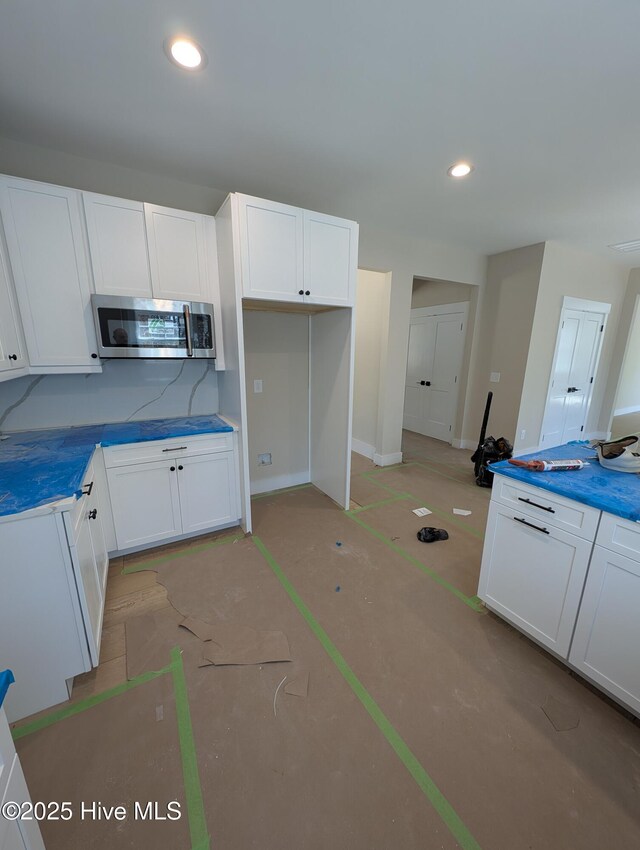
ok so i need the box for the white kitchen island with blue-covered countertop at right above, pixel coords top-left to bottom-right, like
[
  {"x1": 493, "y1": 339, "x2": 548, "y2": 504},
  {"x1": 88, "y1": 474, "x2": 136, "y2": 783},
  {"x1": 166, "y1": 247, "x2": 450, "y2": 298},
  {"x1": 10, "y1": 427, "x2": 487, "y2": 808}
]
[{"x1": 478, "y1": 443, "x2": 640, "y2": 716}]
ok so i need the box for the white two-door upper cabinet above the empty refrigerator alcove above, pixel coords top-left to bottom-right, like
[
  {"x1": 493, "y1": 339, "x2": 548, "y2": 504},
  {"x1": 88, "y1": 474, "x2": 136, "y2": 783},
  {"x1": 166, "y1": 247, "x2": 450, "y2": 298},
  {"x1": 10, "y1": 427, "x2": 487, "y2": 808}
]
[{"x1": 236, "y1": 194, "x2": 358, "y2": 306}]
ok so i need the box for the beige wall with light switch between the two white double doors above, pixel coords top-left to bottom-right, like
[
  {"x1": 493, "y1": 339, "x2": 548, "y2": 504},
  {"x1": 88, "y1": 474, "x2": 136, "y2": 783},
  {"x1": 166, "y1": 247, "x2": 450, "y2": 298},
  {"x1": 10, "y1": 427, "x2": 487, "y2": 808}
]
[{"x1": 463, "y1": 243, "x2": 545, "y2": 445}]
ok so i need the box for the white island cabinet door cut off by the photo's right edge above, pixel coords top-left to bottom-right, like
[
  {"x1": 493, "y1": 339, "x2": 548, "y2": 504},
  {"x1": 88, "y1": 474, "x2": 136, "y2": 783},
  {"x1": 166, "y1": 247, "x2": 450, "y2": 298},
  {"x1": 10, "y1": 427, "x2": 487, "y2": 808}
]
[{"x1": 569, "y1": 546, "x2": 640, "y2": 714}]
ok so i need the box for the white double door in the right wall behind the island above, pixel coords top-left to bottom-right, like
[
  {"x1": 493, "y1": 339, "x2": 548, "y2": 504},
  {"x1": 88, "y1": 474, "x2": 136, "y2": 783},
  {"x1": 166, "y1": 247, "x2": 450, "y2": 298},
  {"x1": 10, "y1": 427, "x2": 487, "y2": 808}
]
[{"x1": 540, "y1": 308, "x2": 606, "y2": 448}]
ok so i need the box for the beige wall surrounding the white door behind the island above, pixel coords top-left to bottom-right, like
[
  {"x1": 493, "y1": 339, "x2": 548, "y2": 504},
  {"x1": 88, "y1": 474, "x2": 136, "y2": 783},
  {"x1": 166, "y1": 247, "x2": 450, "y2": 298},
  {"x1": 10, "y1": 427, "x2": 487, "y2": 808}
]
[{"x1": 514, "y1": 242, "x2": 629, "y2": 451}]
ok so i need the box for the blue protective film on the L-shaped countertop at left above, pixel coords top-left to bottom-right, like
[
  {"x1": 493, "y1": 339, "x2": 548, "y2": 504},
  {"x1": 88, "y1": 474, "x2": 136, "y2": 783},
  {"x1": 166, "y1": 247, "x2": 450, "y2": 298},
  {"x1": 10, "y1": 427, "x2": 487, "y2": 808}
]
[{"x1": 0, "y1": 415, "x2": 233, "y2": 516}]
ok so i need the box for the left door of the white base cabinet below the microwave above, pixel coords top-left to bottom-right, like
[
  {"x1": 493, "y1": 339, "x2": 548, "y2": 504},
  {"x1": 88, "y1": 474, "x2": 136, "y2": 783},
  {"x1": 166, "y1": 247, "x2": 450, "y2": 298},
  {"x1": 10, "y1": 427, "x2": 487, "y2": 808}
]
[{"x1": 107, "y1": 459, "x2": 182, "y2": 550}]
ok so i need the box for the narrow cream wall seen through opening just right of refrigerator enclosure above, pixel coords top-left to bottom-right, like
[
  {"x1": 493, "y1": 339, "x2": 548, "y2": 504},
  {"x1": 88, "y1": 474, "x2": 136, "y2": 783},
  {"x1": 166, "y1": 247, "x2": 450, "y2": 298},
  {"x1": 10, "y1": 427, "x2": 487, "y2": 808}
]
[{"x1": 353, "y1": 270, "x2": 391, "y2": 457}]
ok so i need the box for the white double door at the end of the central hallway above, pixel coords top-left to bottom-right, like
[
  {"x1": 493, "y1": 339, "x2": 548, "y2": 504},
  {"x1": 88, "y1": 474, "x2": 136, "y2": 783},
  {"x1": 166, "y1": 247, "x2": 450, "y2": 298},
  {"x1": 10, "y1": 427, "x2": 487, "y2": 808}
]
[{"x1": 403, "y1": 304, "x2": 466, "y2": 442}]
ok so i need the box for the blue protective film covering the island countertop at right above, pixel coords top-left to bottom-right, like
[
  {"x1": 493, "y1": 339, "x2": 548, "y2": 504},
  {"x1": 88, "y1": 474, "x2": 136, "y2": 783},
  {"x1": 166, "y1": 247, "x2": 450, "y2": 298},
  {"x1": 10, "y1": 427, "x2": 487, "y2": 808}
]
[{"x1": 491, "y1": 442, "x2": 640, "y2": 522}]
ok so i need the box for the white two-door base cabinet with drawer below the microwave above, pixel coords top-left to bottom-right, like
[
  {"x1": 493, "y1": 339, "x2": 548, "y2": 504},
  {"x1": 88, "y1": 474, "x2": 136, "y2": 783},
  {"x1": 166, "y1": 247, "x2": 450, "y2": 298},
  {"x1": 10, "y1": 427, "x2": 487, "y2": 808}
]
[{"x1": 105, "y1": 434, "x2": 239, "y2": 551}]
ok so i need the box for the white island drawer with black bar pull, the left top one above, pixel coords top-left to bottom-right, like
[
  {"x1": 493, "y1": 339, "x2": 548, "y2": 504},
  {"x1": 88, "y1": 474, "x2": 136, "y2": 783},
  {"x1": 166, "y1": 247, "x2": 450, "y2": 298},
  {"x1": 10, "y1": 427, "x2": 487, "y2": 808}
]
[{"x1": 491, "y1": 472, "x2": 600, "y2": 541}]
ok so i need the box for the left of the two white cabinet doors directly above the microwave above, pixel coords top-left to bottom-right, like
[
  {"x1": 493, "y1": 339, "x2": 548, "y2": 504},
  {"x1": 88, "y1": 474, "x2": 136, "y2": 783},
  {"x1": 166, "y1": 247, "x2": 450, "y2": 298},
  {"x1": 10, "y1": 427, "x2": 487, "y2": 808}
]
[{"x1": 82, "y1": 192, "x2": 151, "y2": 298}]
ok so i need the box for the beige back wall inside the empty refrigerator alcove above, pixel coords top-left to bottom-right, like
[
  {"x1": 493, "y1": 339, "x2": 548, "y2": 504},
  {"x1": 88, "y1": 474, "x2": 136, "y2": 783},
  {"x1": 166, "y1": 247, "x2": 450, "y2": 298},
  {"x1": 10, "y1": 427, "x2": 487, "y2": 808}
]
[{"x1": 244, "y1": 310, "x2": 309, "y2": 492}]
